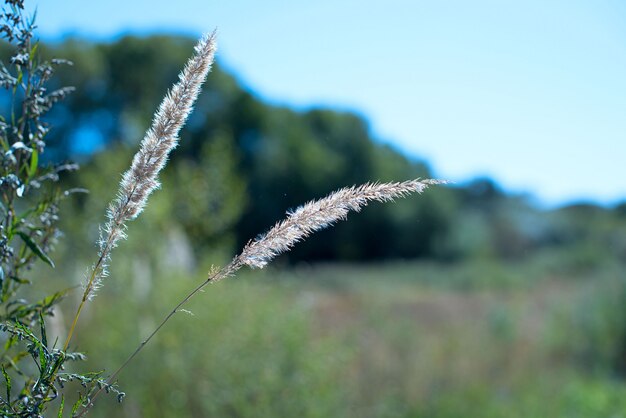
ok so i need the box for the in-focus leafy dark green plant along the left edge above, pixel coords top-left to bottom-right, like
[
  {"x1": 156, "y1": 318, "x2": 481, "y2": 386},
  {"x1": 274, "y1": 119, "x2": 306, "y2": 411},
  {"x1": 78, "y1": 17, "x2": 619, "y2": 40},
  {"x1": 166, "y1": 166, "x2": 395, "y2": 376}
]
[{"x1": 0, "y1": 1, "x2": 109, "y2": 417}]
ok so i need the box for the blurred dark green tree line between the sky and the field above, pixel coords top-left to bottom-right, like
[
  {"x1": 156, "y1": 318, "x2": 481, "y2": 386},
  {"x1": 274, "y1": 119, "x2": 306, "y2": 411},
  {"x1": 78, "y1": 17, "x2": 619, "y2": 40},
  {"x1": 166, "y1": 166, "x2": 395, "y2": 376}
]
[{"x1": 0, "y1": 36, "x2": 626, "y2": 268}]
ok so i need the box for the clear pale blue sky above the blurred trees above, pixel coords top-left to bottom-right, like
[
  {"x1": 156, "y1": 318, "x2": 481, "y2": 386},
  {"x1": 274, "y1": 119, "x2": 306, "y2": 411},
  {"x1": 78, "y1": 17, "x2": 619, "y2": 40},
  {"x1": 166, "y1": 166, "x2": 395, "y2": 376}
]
[{"x1": 31, "y1": 0, "x2": 626, "y2": 206}]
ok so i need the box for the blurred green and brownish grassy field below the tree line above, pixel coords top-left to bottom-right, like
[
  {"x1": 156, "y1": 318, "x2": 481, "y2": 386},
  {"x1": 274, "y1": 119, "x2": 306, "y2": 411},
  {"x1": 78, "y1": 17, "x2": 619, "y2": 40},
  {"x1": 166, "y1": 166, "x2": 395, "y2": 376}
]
[{"x1": 44, "y1": 261, "x2": 626, "y2": 417}]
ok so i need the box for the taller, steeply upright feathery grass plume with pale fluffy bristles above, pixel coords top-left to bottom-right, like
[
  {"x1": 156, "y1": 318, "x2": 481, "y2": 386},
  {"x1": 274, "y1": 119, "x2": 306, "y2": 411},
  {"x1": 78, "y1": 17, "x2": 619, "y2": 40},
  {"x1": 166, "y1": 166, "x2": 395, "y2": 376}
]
[{"x1": 85, "y1": 33, "x2": 216, "y2": 299}]
